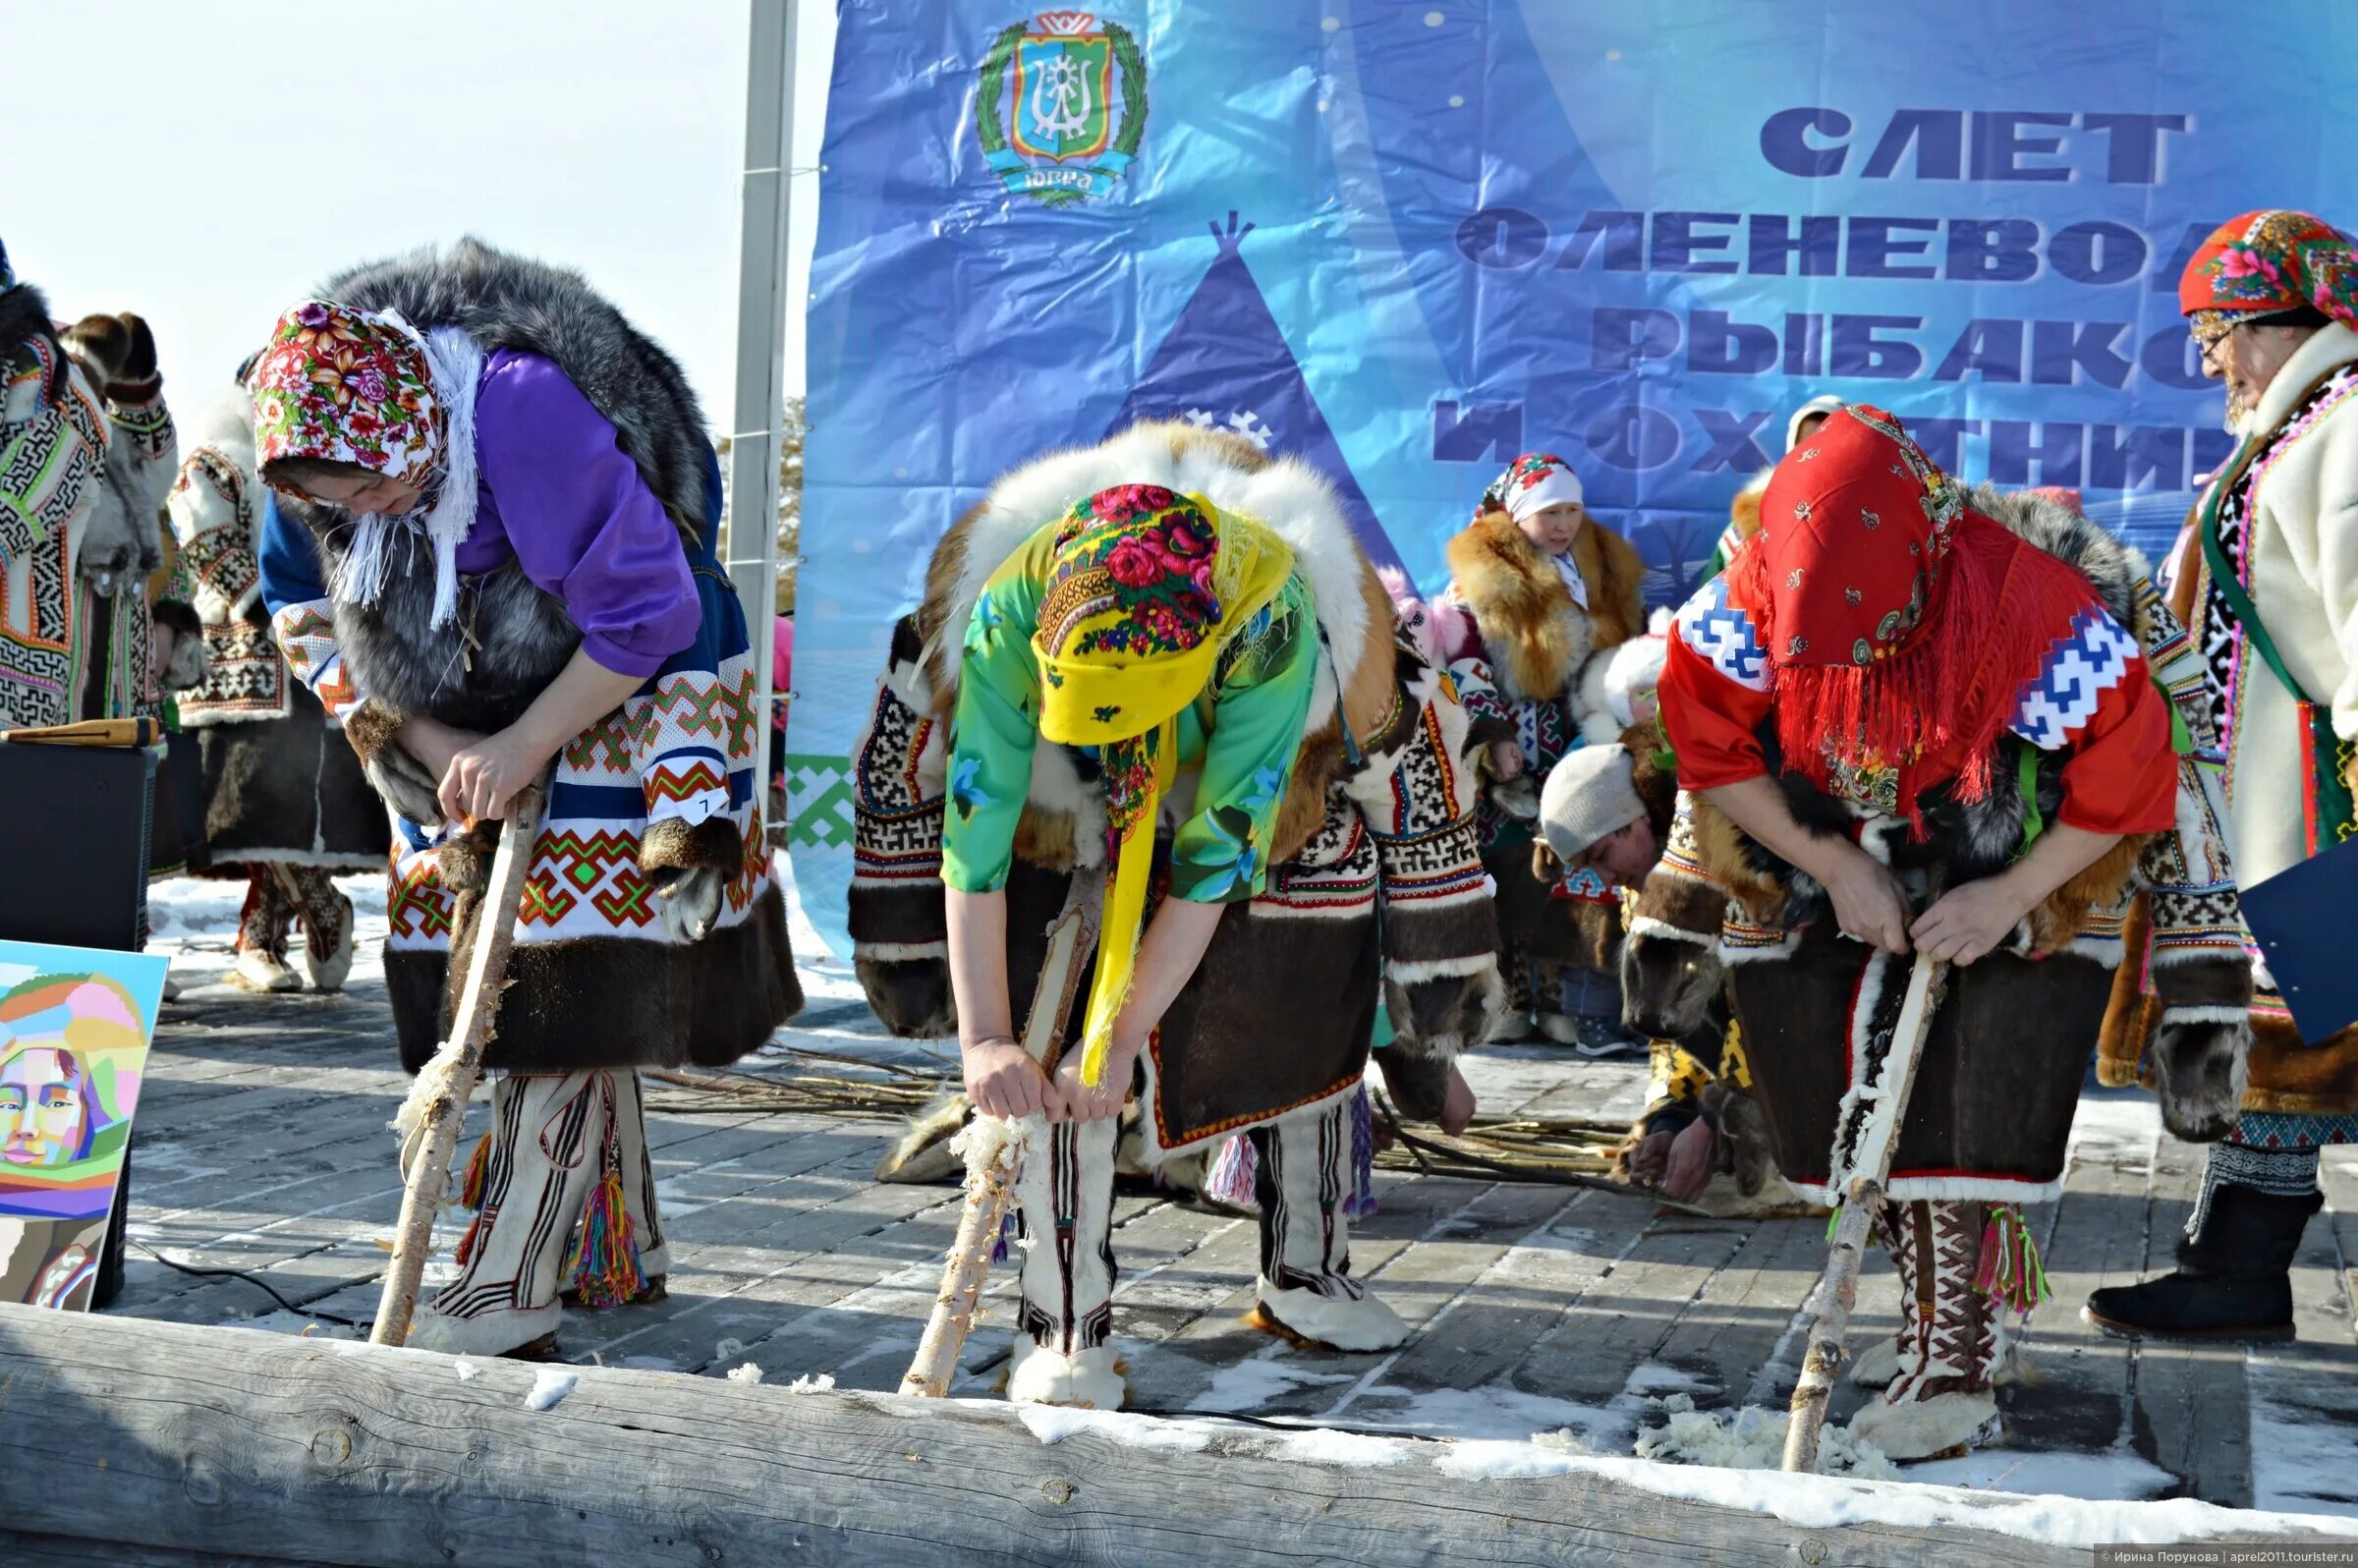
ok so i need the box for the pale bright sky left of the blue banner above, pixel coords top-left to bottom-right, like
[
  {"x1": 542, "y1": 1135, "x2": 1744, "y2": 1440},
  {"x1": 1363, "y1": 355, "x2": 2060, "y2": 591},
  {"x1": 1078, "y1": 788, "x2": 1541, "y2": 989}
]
[{"x1": 0, "y1": 0, "x2": 835, "y2": 413}]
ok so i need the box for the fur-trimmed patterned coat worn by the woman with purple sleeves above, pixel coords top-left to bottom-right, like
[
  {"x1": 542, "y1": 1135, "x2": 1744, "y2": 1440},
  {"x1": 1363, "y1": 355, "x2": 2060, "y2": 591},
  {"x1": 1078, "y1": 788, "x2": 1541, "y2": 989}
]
[{"x1": 261, "y1": 241, "x2": 802, "y2": 1073}]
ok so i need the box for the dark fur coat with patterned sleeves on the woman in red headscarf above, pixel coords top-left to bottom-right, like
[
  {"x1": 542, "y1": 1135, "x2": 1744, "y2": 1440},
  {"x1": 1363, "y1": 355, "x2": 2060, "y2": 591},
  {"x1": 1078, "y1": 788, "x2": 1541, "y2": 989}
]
[{"x1": 1622, "y1": 485, "x2": 2252, "y2": 1198}]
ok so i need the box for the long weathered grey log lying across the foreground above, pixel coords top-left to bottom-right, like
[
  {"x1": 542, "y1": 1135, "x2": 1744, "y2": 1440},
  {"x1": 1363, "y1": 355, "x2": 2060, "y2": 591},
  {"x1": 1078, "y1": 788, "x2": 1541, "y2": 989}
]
[{"x1": 0, "y1": 1307, "x2": 2320, "y2": 1568}]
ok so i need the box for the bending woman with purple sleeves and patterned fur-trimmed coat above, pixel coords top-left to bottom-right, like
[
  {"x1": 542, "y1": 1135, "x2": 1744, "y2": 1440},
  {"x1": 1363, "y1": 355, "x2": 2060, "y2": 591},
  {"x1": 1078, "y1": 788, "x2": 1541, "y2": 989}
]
[{"x1": 248, "y1": 243, "x2": 802, "y2": 1354}]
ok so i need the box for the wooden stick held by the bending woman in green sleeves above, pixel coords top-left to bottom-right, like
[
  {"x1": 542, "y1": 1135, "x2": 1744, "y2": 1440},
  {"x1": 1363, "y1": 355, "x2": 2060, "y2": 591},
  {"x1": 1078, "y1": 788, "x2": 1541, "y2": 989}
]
[{"x1": 901, "y1": 870, "x2": 1106, "y2": 1398}]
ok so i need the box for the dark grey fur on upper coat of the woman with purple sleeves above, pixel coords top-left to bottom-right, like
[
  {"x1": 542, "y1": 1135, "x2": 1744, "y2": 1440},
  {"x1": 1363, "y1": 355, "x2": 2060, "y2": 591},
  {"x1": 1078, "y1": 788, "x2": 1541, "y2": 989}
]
[{"x1": 278, "y1": 241, "x2": 712, "y2": 733}]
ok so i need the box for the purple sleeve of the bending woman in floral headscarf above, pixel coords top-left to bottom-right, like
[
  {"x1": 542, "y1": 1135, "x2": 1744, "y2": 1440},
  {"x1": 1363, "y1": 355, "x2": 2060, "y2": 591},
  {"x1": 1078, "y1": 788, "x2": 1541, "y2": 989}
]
[{"x1": 474, "y1": 354, "x2": 702, "y2": 674}]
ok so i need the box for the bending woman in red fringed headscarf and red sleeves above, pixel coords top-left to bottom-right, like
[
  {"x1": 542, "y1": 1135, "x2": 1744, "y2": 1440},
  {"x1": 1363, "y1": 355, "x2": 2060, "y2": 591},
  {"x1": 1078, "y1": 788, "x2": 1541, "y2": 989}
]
[{"x1": 1660, "y1": 403, "x2": 2179, "y2": 1460}]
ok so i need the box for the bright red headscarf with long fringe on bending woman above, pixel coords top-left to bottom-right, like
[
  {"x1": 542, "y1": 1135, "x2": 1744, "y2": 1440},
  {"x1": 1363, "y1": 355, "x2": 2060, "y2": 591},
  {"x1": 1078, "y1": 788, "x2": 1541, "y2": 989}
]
[{"x1": 1728, "y1": 403, "x2": 2097, "y2": 830}]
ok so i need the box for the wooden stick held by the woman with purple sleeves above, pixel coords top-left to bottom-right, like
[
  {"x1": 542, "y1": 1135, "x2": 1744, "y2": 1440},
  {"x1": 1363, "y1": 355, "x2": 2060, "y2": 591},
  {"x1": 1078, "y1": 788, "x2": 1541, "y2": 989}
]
[{"x1": 367, "y1": 783, "x2": 544, "y2": 1344}]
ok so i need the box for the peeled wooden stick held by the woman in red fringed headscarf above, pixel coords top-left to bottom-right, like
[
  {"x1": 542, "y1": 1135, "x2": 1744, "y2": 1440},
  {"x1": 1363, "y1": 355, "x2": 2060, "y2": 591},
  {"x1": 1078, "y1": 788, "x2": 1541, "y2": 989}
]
[{"x1": 1785, "y1": 953, "x2": 1947, "y2": 1474}]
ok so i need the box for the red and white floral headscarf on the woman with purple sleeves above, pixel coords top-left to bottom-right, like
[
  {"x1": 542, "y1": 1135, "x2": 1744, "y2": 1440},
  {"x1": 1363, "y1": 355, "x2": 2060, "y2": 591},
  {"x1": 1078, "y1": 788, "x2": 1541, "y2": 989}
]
[{"x1": 246, "y1": 300, "x2": 443, "y2": 483}]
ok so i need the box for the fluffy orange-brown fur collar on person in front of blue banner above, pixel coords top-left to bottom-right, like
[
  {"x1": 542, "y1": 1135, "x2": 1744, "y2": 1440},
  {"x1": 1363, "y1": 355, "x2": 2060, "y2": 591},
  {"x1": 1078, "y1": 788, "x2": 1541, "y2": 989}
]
[{"x1": 1448, "y1": 507, "x2": 1646, "y2": 716}]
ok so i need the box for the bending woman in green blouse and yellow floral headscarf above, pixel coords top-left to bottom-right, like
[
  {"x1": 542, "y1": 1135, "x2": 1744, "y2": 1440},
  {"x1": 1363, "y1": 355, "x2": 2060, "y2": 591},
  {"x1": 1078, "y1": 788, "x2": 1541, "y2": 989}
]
[{"x1": 933, "y1": 424, "x2": 1497, "y2": 1410}]
